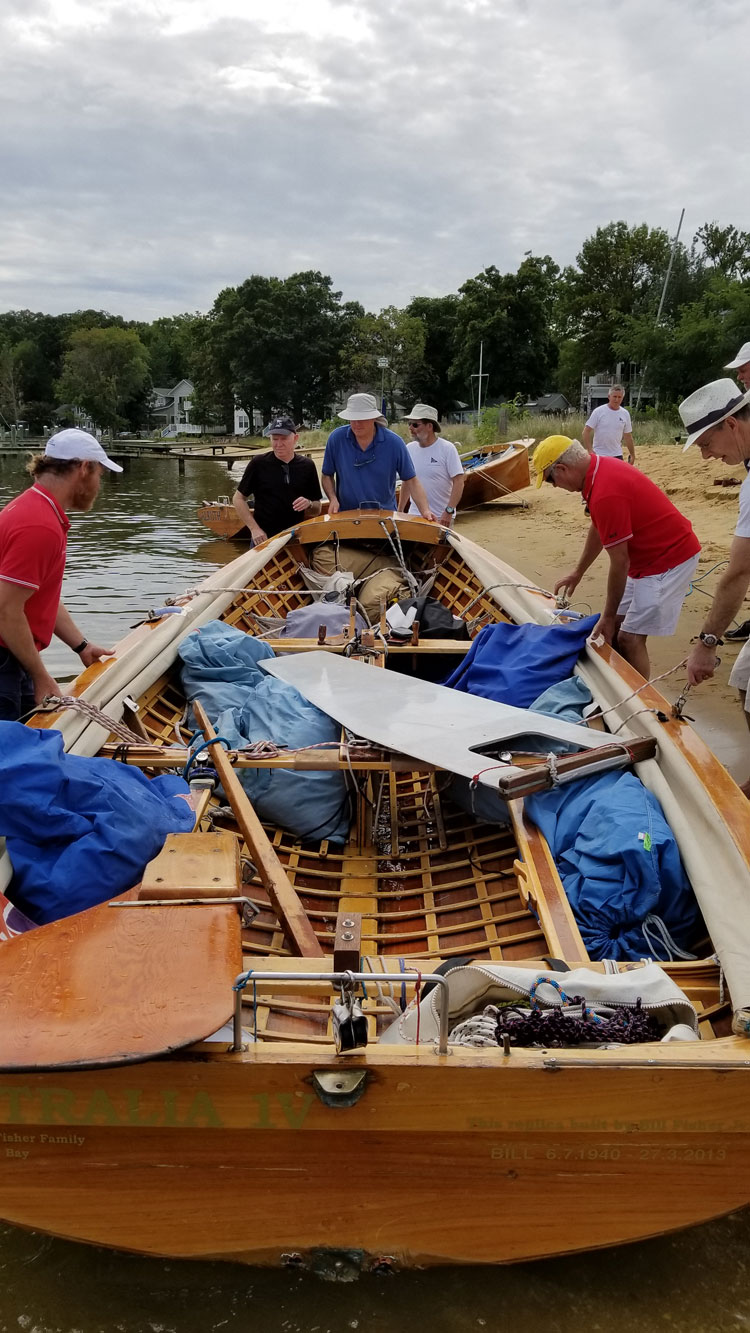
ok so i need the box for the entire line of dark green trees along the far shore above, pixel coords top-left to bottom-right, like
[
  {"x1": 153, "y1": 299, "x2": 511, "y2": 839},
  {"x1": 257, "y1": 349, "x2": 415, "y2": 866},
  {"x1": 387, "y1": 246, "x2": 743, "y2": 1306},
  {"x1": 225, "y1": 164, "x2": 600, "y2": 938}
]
[{"x1": 0, "y1": 221, "x2": 750, "y2": 433}]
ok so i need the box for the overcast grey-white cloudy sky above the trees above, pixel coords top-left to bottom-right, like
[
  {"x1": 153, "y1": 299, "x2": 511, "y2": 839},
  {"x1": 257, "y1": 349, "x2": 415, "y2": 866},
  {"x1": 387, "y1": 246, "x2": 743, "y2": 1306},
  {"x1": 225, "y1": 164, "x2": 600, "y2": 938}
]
[{"x1": 0, "y1": 0, "x2": 750, "y2": 319}]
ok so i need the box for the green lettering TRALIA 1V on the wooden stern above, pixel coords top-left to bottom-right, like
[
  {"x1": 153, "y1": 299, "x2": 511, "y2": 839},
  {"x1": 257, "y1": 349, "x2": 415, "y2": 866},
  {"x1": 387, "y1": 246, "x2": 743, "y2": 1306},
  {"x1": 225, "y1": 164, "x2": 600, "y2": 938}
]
[{"x1": 0, "y1": 1084, "x2": 314, "y2": 1145}]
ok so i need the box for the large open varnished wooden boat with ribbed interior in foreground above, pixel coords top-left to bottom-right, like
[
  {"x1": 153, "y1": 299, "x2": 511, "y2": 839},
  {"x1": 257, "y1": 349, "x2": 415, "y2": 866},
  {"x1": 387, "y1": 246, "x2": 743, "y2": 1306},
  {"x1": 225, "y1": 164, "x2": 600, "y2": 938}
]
[{"x1": 0, "y1": 515, "x2": 750, "y2": 1268}]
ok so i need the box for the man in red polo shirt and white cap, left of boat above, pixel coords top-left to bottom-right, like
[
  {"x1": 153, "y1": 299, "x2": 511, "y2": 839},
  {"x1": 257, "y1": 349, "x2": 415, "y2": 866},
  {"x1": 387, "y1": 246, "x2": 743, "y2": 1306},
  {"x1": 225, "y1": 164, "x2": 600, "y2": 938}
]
[{"x1": 0, "y1": 429, "x2": 123, "y2": 721}]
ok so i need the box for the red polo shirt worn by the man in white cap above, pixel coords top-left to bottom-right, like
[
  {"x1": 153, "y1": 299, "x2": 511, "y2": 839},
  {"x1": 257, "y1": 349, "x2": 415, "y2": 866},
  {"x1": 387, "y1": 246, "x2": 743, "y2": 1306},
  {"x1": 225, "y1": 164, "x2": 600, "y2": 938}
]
[{"x1": 0, "y1": 481, "x2": 71, "y2": 649}]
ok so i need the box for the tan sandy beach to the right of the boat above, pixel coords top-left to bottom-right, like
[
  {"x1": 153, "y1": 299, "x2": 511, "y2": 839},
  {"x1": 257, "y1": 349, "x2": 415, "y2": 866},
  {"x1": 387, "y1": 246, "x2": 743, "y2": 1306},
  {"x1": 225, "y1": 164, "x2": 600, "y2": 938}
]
[{"x1": 458, "y1": 445, "x2": 750, "y2": 781}]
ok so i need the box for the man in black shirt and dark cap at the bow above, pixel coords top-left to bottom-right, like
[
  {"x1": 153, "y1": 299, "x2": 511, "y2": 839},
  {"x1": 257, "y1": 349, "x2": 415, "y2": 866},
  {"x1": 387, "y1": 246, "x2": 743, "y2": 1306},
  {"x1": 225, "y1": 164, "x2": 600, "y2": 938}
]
[{"x1": 232, "y1": 416, "x2": 320, "y2": 545}]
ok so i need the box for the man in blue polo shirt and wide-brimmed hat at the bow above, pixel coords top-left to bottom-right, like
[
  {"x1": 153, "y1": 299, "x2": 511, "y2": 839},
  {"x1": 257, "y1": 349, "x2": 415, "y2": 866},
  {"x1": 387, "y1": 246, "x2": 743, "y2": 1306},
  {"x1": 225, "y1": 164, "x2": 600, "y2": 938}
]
[{"x1": 321, "y1": 393, "x2": 434, "y2": 523}]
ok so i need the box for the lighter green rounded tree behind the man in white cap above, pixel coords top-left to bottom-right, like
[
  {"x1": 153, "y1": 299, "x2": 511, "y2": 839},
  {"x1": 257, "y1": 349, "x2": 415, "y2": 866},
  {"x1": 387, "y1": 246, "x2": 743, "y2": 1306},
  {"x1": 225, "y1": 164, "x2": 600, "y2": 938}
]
[{"x1": 57, "y1": 328, "x2": 148, "y2": 431}]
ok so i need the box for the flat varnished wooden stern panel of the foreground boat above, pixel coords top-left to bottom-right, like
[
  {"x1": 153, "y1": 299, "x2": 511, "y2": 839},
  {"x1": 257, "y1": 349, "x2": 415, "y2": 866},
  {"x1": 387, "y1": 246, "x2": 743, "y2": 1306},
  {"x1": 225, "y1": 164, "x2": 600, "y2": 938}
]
[{"x1": 0, "y1": 1048, "x2": 750, "y2": 1268}]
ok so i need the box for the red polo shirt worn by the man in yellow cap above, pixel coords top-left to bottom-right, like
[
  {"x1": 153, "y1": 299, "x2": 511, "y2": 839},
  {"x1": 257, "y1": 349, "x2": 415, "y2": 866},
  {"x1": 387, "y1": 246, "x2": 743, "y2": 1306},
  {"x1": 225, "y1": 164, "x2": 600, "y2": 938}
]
[{"x1": 583, "y1": 453, "x2": 701, "y2": 579}]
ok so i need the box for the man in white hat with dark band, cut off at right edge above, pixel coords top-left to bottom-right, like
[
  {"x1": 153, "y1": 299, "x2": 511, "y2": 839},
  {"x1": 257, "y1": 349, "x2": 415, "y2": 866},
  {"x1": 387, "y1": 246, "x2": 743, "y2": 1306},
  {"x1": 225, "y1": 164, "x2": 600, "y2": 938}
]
[{"x1": 679, "y1": 378, "x2": 750, "y2": 797}]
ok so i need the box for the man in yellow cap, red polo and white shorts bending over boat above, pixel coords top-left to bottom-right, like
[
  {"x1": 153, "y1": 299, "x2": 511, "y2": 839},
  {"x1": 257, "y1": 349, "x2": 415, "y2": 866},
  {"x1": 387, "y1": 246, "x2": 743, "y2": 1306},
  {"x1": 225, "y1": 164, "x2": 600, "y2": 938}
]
[{"x1": 534, "y1": 435, "x2": 701, "y2": 680}]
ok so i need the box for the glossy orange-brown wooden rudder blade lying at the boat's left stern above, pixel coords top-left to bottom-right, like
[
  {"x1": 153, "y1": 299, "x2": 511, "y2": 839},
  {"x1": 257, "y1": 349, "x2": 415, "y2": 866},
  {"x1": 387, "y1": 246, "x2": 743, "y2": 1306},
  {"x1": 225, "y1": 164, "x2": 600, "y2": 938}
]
[{"x1": 0, "y1": 834, "x2": 242, "y2": 1073}]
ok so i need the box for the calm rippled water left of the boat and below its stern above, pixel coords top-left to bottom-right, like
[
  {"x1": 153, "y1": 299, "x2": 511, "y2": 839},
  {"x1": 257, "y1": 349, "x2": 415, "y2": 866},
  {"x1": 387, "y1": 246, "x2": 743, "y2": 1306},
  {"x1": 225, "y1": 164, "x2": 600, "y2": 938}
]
[{"x1": 0, "y1": 460, "x2": 750, "y2": 1333}]
